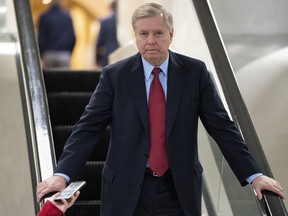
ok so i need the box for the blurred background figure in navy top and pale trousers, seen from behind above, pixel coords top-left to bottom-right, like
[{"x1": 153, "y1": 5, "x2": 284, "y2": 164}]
[{"x1": 38, "y1": 0, "x2": 76, "y2": 68}]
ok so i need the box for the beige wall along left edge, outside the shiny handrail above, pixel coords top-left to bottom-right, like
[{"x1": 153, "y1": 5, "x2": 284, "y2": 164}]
[{"x1": 0, "y1": 1, "x2": 35, "y2": 216}]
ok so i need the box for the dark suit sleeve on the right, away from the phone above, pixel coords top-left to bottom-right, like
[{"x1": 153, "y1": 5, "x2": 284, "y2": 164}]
[{"x1": 200, "y1": 62, "x2": 261, "y2": 185}]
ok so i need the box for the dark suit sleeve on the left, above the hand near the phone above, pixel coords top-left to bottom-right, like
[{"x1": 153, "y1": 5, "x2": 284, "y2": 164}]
[{"x1": 54, "y1": 68, "x2": 113, "y2": 181}]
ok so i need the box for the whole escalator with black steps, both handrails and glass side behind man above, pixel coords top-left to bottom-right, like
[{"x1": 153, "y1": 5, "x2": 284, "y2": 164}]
[{"x1": 1, "y1": 0, "x2": 287, "y2": 216}]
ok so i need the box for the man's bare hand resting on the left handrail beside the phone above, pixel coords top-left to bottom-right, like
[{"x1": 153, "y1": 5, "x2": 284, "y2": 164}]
[{"x1": 36, "y1": 176, "x2": 66, "y2": 202}]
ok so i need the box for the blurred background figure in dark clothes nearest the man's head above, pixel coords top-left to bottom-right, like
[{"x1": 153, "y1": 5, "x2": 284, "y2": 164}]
[{"x1": 96, "y1": 0, "x2": 119, "y2": 67}]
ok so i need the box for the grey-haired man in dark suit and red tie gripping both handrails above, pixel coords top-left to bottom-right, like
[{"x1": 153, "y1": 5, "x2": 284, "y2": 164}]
[{"x1": 37, "y1": 3, "x2": 284, "y2": 216}]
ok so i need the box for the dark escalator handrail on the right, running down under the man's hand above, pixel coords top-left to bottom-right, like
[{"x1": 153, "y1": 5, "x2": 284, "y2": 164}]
[{"x1": 193, "y1": 0, "x2": 288, "y2": 216}]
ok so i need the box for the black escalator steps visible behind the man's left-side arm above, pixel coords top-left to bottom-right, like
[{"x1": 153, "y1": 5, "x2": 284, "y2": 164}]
[{"x1": 43, "y1": 70, "x2": 109, "y2": 216}]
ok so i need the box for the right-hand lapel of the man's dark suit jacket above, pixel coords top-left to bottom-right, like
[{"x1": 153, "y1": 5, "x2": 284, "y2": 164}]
[{"x1": 167, "y1": 52, "x2": 186, "y2": 138}]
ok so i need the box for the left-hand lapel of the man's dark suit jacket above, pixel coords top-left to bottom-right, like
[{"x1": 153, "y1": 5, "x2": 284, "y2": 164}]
[{"x1": 126, "y1": 53, "x2": 149, "y2": 131}]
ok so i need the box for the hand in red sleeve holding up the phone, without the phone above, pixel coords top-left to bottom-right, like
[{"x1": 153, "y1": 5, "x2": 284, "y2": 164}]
[{"x1": 37, "y1": 191, "x2": 80, "y2": 216}]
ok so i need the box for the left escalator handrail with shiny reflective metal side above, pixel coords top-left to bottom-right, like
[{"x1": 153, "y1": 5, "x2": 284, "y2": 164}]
[{"x1": 13, "y1": 0, "x2": 56, "y2": 212}]
